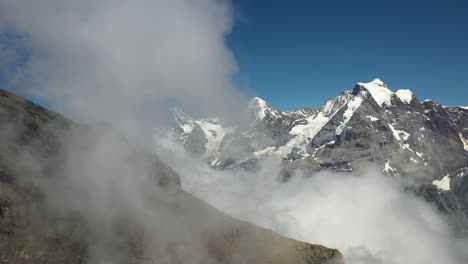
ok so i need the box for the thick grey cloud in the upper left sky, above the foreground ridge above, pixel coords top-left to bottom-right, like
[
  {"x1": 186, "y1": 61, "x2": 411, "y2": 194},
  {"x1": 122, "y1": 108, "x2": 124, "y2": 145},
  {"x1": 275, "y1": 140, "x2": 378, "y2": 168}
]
[{"x1": 0, "y1": 0, "x2": 244, "y2": 134}]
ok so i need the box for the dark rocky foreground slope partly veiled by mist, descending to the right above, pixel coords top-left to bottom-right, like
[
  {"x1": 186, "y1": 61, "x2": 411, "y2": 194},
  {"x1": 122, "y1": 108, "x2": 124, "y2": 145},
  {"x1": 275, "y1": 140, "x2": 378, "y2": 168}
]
[{"x1": 0, "y1": 90, "x2": 342, "y2": 264}]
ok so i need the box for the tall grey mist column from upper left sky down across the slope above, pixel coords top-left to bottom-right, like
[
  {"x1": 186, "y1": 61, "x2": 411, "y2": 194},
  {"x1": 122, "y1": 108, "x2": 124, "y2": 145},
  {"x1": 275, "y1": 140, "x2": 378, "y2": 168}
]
[{"x1": 0, "y1": 0, "x2": 250, "y2": 264}]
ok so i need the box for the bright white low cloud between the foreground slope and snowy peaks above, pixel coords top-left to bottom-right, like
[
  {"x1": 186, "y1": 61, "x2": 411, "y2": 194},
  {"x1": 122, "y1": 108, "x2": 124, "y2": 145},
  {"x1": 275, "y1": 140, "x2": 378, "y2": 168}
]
[{"x1": 157, "y1": 140, "x2": 468, "y2": 264}]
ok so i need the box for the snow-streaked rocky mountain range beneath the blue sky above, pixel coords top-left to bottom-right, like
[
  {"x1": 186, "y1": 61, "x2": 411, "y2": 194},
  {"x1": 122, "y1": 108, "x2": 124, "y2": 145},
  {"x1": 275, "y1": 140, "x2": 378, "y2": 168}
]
[{"x1": 171, "y1": 79, "x2": 468, "y2": 230}]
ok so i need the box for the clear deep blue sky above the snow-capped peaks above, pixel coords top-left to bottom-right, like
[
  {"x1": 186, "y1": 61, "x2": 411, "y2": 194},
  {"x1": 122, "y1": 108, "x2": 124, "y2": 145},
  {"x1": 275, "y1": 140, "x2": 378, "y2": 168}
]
[{"x1": 228, "y1": 0, "x2": 468, "y2": 110}]
